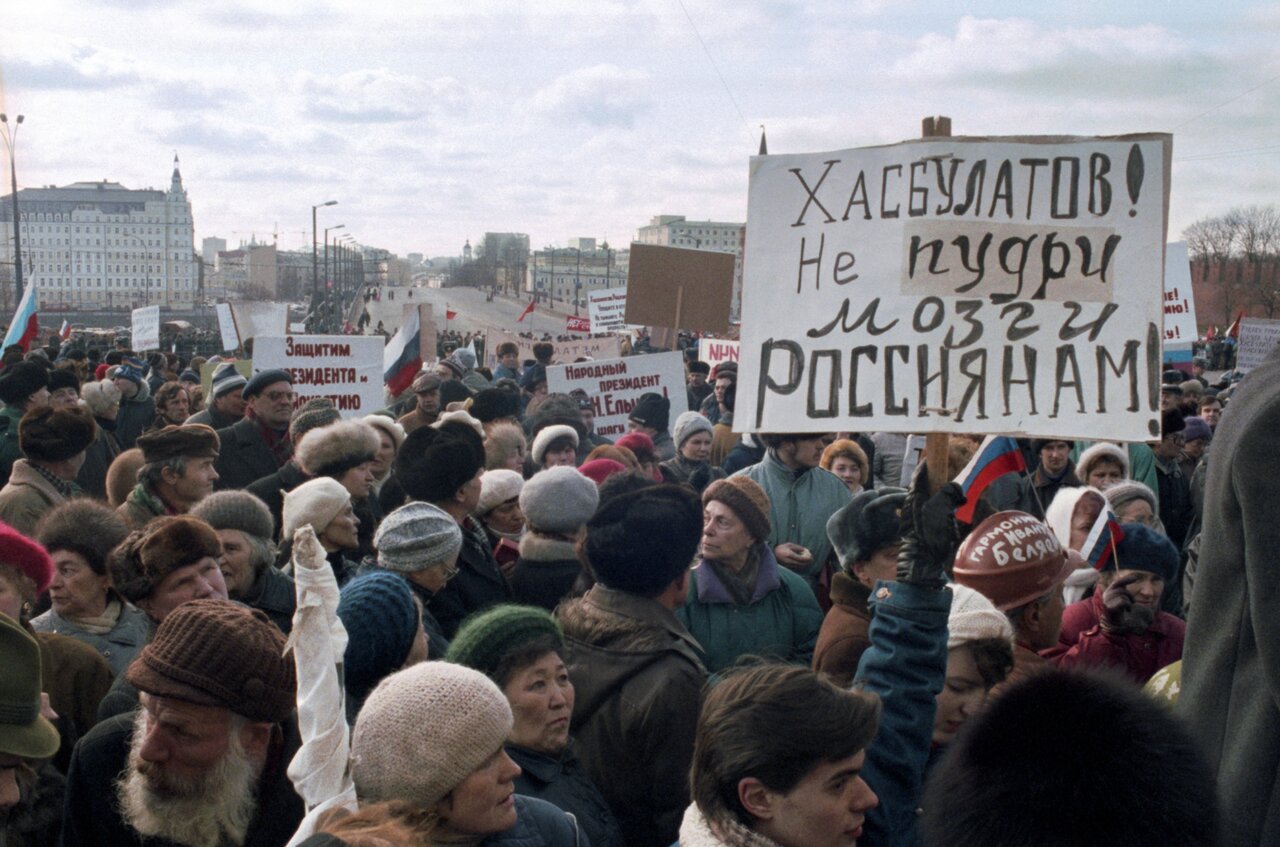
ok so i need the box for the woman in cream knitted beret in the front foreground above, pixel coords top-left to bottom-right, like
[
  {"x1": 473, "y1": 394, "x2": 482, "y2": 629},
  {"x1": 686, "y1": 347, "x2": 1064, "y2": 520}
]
[{"x1": 351, "y1": 661, "x2": 586, "y2": 847}]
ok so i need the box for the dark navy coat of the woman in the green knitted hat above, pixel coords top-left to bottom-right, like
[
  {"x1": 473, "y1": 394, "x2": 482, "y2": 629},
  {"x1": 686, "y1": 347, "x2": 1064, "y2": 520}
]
[{"x1": 507, "y1": 741, "x2": 625, "y2": 847}]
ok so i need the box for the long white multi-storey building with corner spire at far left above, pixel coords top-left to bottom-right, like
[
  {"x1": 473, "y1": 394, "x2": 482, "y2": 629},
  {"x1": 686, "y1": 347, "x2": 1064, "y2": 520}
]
[{"x1": 0, "y1": 156, "x2": 198, "y2": 311}]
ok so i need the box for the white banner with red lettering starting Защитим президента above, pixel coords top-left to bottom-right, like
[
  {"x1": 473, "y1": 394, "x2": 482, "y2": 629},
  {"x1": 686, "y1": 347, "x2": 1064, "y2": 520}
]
[{"x1": 253, "y1": 335, "x2": 385, "y2": 417}]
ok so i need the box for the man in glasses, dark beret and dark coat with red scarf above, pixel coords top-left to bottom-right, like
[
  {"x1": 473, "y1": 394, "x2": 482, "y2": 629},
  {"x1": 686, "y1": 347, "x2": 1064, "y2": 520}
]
[{"x1": 216, "y1": 370, "x2": 293, "y2": 490}]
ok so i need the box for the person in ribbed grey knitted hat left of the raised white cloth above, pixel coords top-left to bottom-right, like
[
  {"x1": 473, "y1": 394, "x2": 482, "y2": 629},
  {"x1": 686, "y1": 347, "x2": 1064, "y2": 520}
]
[{"x1": 191, "y1": 490, "x2": 298, "y2": 635}]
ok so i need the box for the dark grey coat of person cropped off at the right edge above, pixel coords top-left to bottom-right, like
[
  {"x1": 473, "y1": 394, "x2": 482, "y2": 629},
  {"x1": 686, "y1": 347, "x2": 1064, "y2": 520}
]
[{"x1": 1178, "y1": 348, "x2": 1280, "y2": 847}]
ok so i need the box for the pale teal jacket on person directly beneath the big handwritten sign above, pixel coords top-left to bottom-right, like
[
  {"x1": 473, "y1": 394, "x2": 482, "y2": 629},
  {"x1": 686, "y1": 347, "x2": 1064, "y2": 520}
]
[{"x1": 733, "y1": 450, "x2": 852, "y2": 591}]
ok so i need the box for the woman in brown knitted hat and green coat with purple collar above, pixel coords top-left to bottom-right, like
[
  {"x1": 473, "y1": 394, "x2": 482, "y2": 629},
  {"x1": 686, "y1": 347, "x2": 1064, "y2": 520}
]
[{"x1": 676, "y1": 476, "x2": 822, "y2": 673}]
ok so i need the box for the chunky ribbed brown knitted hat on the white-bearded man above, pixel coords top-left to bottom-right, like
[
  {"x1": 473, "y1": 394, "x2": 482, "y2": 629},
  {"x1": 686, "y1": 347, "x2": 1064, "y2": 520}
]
[{"x1": 125, "y1": 600, "x2": 297, "y2": 723}]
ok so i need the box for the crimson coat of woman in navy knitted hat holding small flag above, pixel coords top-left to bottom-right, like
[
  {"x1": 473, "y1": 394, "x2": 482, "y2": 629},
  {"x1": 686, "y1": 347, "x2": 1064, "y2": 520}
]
[{"x1": 1041, "y1": 591, "x2": 1187, "y2": 685}]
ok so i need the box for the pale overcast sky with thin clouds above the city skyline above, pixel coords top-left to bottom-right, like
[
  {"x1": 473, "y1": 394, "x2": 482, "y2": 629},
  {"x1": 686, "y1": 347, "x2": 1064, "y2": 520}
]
[{"x1": 0, "y1": 0, "x2": 1280, "y2": 256}]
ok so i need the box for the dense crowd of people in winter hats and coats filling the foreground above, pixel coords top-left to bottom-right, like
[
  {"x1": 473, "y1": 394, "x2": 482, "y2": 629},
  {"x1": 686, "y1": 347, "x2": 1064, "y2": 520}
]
[{"x1": 0, "y1": 326, "x2": 1280, "y2": 847}]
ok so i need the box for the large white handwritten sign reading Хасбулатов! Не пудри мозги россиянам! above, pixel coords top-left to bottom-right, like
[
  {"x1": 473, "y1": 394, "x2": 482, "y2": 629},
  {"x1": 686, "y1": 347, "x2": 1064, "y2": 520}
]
[{"x1": 735, "y1": 134, "x2": 1171, "y2": 440}]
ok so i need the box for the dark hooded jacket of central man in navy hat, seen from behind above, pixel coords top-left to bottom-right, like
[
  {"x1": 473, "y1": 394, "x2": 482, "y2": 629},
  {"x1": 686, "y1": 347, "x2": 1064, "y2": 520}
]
[{"x1": 557, "y1": 585, "x2": 707, "y2": 847}]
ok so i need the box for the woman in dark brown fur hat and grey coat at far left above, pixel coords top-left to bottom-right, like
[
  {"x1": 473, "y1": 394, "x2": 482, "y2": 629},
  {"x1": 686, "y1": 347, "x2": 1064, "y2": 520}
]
[{"x1": 31, "y1": 498, "x2": 151, "y2": 676}]
